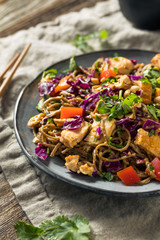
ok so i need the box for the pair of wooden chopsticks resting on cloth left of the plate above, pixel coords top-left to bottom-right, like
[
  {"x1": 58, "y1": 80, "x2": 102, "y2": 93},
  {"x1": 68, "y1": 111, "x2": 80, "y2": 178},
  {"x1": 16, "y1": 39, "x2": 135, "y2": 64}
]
[{"x1": 0, "y1": 43, "x2": 31, "y2": 97}]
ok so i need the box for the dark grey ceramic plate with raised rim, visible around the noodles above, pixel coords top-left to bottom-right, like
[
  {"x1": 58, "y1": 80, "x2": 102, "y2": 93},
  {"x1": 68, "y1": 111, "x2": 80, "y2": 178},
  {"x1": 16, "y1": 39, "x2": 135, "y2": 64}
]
[{"x1": 14, "y1": 49, "x2": 160, "y2": 196}]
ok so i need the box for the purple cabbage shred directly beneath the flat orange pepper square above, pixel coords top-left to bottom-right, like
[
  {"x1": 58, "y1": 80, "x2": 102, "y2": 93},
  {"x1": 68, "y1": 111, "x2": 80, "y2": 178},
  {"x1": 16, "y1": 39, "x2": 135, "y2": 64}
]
[{"x1": 63, "y1": 116, "x2": 84, "y2": 130}]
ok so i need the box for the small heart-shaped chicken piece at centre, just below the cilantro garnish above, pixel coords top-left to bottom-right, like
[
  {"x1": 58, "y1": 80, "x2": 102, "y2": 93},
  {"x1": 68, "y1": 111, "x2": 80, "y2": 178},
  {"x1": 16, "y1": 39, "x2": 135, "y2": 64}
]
[{"x1": 101, "y1": 118, "x2": 116, "y2": 139}]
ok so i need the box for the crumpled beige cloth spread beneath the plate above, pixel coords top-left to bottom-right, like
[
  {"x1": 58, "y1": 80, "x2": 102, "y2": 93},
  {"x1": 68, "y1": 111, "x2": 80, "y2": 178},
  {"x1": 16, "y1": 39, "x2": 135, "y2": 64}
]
[{"x1": 0, "y1": 0, "x2": 160, "y2": 240}]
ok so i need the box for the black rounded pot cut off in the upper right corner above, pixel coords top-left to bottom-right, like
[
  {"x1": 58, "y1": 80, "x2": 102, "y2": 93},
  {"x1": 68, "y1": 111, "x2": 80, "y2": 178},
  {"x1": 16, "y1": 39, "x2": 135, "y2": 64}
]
[{"x1": 119, "y1": 0, "x2": 160, "y2": 30}]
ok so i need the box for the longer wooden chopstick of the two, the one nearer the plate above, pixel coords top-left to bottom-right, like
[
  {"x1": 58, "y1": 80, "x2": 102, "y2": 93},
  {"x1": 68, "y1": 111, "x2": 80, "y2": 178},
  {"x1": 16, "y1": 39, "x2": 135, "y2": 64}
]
[{"x1": 0, "y1": 43, "x2": 31, "y2": 97}]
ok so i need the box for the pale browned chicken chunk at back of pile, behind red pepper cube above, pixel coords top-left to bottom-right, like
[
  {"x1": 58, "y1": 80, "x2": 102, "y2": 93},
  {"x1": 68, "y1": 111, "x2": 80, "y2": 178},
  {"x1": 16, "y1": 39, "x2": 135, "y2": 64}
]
[{"x1": 109, "y1": 57, "x2": 134, "y2": 75}]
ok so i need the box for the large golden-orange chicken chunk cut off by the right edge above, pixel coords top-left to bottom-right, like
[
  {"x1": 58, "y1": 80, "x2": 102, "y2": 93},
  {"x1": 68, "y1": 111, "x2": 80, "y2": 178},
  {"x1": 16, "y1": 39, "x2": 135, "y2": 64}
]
[{"x1": 134, "y1": 128, "x2": 160, "y2": 158}]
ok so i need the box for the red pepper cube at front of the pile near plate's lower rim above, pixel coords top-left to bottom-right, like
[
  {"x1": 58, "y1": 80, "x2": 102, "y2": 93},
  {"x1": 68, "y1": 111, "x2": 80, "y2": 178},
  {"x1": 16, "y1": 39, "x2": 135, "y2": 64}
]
[{"x1": 117, "y1": 166, "x2": 140, "y2": 186}]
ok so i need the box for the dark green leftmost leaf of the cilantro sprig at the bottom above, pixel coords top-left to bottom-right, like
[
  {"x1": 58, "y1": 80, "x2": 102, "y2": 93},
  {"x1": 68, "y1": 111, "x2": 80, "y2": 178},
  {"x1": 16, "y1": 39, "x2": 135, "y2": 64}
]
[{"x1": 15, "y1": 221, "x2": 43, "y2": 240}]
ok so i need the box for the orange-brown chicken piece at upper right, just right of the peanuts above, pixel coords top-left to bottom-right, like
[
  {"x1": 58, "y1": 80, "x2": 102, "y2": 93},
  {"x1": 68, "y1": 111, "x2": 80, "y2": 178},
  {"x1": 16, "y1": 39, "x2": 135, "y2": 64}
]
[{"x1": 134, "y1": 81, "x2": 152, "y2": 104}]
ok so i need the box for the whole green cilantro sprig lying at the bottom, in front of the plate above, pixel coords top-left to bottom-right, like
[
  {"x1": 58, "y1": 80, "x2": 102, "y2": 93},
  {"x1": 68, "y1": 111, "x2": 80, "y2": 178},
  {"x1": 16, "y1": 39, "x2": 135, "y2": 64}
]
[{"x1": 15, "y1": 215, "x2": 91, "y2": 240}]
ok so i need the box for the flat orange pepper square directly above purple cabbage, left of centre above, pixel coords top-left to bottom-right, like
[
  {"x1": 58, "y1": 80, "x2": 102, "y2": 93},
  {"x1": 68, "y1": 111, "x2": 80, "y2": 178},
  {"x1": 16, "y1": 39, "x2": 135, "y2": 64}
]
[{"x1": 61, "y1": 107, "x2": 83, "y2": 119}]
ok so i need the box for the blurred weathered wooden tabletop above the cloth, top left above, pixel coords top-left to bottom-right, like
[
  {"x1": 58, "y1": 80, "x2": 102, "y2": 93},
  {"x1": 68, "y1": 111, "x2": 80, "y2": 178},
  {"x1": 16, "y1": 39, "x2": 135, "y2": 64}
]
[{"x1": 0, "y1": 0, "x2": 104, "y2": 37}]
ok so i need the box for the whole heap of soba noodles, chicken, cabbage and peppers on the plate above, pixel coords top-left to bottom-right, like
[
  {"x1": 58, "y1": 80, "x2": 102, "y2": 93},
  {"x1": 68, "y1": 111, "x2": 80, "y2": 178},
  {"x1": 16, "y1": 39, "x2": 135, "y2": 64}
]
[{"x1": 28, "y1": 54, "x2": 160, "y2": 185}]
